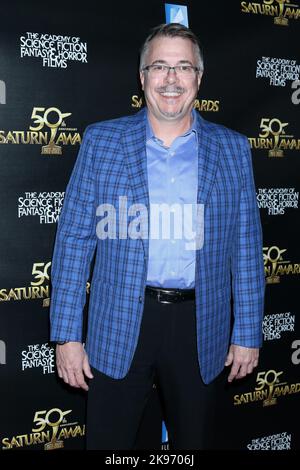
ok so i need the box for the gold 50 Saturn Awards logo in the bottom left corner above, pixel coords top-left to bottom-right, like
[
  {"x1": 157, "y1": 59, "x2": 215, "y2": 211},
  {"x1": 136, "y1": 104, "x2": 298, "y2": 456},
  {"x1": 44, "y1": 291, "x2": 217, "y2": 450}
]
[{"x1": 2, "y1": 408, "x2": 85, "y2": 450}]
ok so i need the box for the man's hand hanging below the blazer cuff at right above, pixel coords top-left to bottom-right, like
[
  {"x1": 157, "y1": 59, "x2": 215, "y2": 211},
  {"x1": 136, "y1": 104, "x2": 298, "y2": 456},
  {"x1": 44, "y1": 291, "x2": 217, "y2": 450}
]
[{"x1": 225, "y1": 344, "x2": 259, "y2": 382}]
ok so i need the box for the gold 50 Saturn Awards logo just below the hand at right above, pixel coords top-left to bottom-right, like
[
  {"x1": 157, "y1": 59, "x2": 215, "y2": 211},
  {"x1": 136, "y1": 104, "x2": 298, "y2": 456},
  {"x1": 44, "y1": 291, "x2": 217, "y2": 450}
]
[{"x1": 233, "y1": 369, "x2": 300, "y2": 406}]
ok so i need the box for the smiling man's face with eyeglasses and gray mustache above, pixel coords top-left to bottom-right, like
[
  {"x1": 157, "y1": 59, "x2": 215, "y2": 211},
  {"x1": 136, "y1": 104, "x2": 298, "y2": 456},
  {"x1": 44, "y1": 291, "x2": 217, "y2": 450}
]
[{"x1": 140, "y1": 37, "x2": 202, "y2": 122}]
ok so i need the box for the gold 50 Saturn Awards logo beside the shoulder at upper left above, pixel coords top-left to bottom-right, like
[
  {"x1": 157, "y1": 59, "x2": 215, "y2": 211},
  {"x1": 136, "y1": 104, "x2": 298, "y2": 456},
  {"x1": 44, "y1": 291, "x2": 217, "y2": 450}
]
[{"x1": 0, "y1": 107, "x2": 81, "y2": 155}]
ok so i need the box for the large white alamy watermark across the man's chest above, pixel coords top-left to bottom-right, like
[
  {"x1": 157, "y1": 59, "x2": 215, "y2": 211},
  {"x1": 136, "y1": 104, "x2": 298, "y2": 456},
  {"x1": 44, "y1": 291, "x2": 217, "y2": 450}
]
[{"x1": 96, "y1": 196, "x2": 204, "y2": 251}]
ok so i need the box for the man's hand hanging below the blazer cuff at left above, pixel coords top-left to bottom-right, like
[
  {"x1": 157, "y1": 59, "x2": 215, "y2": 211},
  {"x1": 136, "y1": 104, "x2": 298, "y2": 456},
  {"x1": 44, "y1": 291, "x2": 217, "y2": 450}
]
[{"x1": 56, "y1": 341, "x2": 94, "y2": 391}]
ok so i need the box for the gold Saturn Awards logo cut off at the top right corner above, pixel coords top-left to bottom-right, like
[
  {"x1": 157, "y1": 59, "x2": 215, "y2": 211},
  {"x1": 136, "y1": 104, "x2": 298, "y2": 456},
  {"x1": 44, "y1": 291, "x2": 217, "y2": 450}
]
[{"x1": 241, "y1": 0, "x2": 300, "y2": 26}]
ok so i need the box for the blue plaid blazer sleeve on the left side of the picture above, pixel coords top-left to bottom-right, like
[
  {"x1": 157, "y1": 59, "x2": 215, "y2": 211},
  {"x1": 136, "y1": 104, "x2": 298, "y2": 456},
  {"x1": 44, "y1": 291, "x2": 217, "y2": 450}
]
[{"x1": 50, "y1": 127, "x2": 97, "y2": 342}]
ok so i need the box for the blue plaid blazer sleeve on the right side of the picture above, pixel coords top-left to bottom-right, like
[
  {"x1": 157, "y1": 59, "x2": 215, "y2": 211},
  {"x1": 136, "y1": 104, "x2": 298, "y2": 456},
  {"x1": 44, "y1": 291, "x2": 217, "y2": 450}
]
[{"x1": 231, "y1": 138, "x2": 265, "y2": 348}]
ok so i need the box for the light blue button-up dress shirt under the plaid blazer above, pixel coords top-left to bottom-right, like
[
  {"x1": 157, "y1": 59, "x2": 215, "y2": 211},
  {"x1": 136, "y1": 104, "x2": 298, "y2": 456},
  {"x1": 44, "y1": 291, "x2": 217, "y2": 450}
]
[{"x1": 146, "y1": 111, "x2": 198, "y2": 289}]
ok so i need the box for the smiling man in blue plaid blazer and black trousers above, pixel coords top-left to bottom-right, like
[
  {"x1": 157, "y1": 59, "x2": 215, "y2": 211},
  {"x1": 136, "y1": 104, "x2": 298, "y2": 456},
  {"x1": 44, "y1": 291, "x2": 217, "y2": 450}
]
[{"x1": 51, "y1": 24, "x2": 264, "y2": 449}]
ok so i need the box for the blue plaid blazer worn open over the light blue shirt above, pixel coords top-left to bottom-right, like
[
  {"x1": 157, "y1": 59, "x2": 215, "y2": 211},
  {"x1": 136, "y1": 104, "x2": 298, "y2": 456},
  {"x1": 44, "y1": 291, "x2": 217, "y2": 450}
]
[{"x1": 50, "y1": 109, "x2": 265, "y2": 383}]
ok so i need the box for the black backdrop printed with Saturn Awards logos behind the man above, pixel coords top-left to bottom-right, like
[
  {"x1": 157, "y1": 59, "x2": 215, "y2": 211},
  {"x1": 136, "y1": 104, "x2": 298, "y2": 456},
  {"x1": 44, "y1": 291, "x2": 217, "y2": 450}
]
[{"x1": 0, "y1": 0, "x2": 300, "y2": 451}]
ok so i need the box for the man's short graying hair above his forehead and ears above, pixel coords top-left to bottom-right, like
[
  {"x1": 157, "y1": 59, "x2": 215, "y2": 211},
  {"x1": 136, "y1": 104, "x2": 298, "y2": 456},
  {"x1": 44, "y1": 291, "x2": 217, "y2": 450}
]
[{"x1": 140, "y1": 23, "x2": 204, "y2": 72}]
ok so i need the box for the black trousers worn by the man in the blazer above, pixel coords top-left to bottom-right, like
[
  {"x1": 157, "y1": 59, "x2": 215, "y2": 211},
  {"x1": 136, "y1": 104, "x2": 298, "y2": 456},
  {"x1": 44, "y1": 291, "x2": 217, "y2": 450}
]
[{"x1": 87, "y1": 294, "x2": 216, "y2": 450}]
